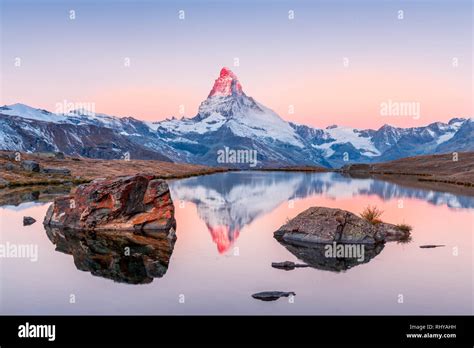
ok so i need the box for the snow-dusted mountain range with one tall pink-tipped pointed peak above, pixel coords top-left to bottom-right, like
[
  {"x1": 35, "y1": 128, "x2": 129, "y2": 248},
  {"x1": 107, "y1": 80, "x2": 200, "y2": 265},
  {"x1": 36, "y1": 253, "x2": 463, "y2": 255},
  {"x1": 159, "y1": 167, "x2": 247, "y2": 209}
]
[{"x1": 0, "y1": 68, "x2": 474, "y2": 168}]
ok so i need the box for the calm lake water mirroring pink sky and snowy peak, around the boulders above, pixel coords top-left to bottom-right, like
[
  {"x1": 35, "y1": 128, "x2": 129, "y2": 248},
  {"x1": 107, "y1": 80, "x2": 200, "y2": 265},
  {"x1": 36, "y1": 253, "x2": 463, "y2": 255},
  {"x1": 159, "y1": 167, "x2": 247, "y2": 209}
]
[{"x1": 0, "y1": 172, "x2": 474, "y2": 315}]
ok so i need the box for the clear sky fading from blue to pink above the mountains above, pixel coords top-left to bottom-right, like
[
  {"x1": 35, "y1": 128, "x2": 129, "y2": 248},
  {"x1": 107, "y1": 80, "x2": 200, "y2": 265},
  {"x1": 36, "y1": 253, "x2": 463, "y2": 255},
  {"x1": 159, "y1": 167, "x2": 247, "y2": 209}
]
[{"x1": 0, "y1": 0, "x2": 473, "y2": 128}]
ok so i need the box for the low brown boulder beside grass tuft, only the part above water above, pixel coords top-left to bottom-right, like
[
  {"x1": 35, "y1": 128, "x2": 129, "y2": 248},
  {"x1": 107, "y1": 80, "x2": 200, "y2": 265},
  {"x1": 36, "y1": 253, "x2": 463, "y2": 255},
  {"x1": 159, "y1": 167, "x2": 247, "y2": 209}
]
[{"x1": 274, "y1": 207, "x2": 409, "y2": 244}]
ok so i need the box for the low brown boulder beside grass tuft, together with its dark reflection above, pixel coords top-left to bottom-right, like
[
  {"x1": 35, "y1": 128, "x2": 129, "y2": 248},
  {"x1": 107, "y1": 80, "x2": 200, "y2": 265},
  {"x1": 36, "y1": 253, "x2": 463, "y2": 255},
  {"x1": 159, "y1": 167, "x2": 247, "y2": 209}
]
[{"x1": 274, "y1": 207, "x2": 410, "y2": 272}]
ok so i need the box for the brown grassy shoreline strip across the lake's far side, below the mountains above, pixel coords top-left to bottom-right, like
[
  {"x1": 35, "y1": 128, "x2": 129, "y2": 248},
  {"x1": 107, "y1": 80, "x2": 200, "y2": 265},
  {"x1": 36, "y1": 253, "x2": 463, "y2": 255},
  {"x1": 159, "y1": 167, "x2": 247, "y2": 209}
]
[{"x1": 0, "y1": 151, "x2": 474, "y2": 196}]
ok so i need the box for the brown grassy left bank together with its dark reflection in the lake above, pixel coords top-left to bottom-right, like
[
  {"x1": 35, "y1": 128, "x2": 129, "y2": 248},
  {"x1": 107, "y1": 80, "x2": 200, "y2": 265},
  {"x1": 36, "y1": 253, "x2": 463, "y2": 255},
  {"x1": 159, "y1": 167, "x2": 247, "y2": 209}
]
[{"x1": 0, "y1": 151, "x2": 227, "y2": 205}]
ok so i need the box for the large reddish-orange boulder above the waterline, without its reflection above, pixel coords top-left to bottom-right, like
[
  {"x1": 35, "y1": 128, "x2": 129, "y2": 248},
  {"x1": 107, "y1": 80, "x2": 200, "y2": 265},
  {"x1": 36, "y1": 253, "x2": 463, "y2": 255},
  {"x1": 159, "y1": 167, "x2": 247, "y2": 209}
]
[{"x1": 43, "y1": 174, "x2": 176, "y2": 230}]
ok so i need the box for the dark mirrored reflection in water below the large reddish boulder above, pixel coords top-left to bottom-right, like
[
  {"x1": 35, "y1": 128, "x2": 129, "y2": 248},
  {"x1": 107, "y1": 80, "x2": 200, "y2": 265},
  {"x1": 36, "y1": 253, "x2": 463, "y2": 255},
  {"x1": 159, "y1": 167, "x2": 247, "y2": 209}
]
[{"x1": 45, "y1": 226, "x2": 176, "y2": 284}]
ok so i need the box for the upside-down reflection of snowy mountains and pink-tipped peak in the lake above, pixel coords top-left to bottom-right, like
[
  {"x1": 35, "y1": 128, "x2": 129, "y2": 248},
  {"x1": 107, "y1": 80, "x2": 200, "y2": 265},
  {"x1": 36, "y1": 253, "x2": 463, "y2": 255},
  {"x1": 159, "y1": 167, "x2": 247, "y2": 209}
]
[{"x1": 170, "y1": 172, "x2": 474, "y2": 253}]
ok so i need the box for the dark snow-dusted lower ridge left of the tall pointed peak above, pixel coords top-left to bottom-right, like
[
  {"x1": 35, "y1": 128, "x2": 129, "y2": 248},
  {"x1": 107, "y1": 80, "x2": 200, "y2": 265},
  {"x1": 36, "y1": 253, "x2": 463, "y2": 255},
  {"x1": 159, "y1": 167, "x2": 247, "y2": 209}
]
[{"x1": 0, "y1": 104, "x2": 175, "y2": 161}]
